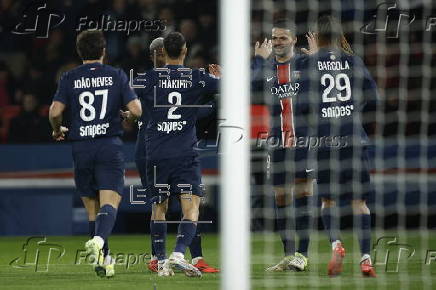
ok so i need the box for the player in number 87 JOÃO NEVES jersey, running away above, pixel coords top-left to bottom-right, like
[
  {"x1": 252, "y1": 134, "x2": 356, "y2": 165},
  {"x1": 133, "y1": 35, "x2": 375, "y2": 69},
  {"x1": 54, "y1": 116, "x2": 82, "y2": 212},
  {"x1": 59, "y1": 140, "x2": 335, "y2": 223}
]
[{"x1": 49, "y1": 31, "x2": 142, "y2": 277}]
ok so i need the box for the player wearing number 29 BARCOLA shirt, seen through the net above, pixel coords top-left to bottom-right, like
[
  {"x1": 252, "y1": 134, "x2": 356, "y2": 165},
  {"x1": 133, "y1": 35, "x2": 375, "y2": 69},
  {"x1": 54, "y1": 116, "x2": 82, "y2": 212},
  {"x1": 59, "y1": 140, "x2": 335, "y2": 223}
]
[{"x1": 296, "y1": 16, "x2": 378, "y2": 277}]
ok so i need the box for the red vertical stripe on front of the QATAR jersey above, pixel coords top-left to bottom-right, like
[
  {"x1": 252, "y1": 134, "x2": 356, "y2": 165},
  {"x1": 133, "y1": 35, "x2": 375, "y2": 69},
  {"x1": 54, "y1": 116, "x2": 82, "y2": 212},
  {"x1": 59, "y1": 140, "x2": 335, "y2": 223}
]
[{"x1": 277, "y1": 64, "x2": 295, "y2": 148}]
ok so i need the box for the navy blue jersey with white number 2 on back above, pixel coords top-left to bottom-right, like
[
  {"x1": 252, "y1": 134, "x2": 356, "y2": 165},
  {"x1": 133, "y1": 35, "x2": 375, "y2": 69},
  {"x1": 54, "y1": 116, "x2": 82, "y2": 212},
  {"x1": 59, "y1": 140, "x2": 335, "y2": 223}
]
[{"x1": 135, "y1": 65, "x2": 218, "y2": 160}]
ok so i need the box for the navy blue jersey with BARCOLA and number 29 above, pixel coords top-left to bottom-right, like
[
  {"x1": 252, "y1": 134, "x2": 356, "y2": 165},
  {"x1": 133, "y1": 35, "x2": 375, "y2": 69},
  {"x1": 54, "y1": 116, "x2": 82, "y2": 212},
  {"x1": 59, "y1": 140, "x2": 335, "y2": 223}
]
[{"x1": 295, "y1": 48, "x2": 378, "y2": 148}]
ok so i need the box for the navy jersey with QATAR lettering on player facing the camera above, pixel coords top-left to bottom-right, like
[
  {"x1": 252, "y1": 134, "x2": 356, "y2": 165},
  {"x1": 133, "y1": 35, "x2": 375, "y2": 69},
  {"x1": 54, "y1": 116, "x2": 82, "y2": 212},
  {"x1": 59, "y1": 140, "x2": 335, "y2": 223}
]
[{"x1": 251, "y1": 55, "x2": 307, "y2": 147}]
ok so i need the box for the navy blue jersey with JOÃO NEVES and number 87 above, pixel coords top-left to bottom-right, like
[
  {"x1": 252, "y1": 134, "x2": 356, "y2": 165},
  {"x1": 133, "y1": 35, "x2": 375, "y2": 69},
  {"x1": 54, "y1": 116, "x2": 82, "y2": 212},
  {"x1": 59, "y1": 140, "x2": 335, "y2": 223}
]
[{"x1": 53, "y1": 63, "x2": 137, "y2": 140}]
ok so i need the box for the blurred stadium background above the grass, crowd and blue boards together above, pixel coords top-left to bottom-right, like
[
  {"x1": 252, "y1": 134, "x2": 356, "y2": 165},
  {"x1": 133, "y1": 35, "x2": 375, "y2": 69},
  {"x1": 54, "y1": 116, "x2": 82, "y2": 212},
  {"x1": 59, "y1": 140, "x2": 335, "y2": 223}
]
[{"x1": 0, "y1": 0, "x2": 436, "y2": 235}]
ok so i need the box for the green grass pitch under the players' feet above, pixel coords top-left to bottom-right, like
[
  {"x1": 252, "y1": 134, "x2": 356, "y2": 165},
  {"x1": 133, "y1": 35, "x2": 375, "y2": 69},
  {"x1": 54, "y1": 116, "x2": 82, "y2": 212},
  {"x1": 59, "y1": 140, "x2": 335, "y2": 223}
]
[{"x1": 0, "y1": 231, "x2": 436, "y2": 290}]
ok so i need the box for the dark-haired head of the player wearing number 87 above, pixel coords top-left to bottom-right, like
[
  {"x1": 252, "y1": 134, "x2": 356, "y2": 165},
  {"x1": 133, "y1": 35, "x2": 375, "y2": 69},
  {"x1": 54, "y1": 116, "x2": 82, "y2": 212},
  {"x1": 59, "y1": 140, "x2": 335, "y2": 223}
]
[{"x1": 76, "y1": 30, "x2": 106, "y2": 60}]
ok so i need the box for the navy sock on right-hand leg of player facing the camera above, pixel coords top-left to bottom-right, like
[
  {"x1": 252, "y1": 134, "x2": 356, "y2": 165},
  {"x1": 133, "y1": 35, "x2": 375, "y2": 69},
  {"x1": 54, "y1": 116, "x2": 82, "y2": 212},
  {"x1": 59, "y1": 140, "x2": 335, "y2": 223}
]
[{"x1": 295, "y1": 196, "x2": 312, "y2": 257}]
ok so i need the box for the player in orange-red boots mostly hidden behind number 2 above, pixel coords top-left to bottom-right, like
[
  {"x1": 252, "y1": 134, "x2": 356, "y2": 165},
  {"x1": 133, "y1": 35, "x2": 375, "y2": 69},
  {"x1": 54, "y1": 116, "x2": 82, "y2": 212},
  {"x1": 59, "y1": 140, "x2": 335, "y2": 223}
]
[{"x1": 130, "y1": 37, "x2": 219, "y2": 273}]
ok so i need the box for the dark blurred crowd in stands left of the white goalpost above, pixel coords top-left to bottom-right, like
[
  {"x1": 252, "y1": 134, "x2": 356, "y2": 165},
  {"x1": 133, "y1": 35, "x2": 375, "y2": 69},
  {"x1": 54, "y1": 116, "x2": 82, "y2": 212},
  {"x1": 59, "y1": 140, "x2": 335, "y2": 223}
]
[{"x1": 0, "y1": 0, "x2": 218, "y2": 143}]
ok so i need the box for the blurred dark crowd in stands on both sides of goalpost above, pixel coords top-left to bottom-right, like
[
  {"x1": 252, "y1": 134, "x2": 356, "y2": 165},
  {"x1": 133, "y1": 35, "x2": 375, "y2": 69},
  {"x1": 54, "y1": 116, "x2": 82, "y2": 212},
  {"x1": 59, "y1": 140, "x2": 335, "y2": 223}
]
[{"x1": 0, "y1": 0, "x2": 436, "y2": 143}]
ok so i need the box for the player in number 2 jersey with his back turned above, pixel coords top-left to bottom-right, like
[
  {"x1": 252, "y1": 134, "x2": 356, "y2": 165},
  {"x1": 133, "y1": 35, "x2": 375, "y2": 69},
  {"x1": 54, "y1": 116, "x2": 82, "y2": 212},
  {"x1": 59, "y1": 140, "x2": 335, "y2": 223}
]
[{"x1": 137, "y1": 32, "x2": 218, "y2": 276}]
